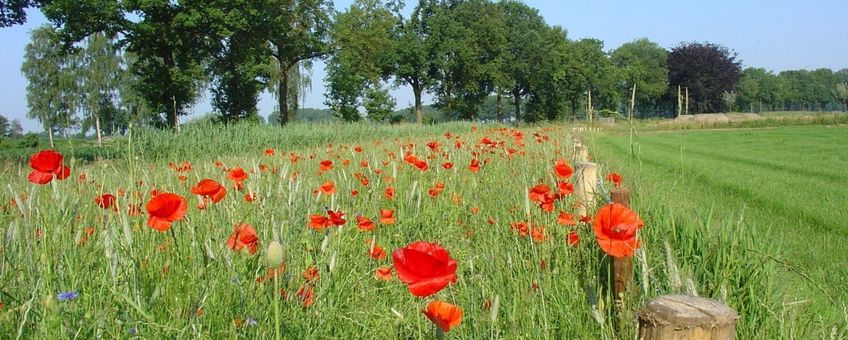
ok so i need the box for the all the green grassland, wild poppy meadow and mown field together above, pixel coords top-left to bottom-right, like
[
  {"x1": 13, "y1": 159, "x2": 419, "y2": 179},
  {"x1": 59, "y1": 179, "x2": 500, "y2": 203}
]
[{"x1": 0, "y1": 123, "x2": 848, "y2": 339}]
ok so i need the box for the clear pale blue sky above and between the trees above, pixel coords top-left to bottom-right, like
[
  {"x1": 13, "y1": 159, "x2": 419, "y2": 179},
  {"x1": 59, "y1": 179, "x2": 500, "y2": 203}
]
[{"x1": 0, "y1": 0, "x2": 848, "y2": 131}]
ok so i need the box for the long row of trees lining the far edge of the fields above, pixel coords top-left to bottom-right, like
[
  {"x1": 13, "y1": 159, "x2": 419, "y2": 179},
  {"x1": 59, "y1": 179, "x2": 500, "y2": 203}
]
[{"x1": 0, "y1": 0, "x2": 848, "y2": 135}]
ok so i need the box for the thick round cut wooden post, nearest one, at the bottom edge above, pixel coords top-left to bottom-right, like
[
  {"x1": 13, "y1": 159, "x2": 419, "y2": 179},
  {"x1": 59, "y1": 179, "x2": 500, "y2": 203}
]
[{"x1": 639, "y1": 295, "x2": 739, "y2": 340}]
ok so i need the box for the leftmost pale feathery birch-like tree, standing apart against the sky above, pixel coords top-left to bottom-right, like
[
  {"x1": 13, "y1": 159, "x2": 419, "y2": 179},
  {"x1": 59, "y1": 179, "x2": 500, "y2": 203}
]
[{"x1": 21, "y1": 25, "x2": 77, "y2": 147}]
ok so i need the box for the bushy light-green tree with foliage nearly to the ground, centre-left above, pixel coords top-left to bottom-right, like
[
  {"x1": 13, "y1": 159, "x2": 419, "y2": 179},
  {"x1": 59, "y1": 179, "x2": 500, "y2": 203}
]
[{"x1": 326, "y1": 0, "x2": 397, "y2": 120}]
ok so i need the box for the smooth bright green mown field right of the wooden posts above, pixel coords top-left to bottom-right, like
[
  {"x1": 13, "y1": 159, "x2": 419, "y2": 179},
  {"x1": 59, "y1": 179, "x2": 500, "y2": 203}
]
[{"x1": 589, "y1": 126, "x2": 848, "y2": 323}]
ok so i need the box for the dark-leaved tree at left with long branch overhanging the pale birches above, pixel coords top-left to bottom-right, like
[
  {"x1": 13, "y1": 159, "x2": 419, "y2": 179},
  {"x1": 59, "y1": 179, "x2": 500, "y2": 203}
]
[{"x1": 41, "y1": 0, "x2": 215, "y2": 129}]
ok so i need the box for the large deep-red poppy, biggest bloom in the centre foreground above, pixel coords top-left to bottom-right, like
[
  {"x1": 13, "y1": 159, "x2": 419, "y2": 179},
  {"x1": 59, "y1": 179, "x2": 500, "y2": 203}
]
[{"x1": 392, "y1": 241, "x2": 456, "y2": 297}]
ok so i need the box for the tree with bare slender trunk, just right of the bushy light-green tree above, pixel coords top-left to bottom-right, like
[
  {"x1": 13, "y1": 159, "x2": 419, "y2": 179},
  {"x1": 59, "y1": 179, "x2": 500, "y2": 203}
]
[{"x1": 393, "y1": 0, "x2": 436, "y2": 124}]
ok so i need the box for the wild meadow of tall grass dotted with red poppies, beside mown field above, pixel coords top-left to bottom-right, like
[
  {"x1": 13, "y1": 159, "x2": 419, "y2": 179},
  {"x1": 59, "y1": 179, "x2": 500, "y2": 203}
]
[{"x1": 0, "y1": 123, "x2": 845, "y2": 339}]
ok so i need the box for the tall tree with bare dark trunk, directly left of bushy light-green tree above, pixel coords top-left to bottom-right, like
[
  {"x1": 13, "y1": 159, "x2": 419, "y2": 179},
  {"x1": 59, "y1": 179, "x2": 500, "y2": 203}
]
[{"x1": 265, "y1": 0, "x2": 333, "y2": 125}]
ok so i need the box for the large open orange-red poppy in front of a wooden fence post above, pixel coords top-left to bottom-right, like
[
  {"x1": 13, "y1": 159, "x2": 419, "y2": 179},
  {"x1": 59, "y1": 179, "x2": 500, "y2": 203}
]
[{"x1": 594, "y1": 203, "x2": 645, "y2": 257}]
